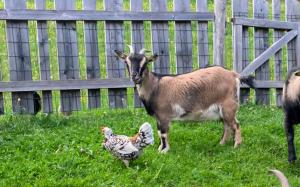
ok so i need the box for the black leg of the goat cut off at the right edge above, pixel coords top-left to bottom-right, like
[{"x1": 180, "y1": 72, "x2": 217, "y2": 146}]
[{"x1": 284, "y1": 116, "x2": 297, "y2": 162}]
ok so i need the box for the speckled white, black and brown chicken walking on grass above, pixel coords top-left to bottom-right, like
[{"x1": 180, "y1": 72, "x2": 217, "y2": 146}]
[{"x1": 101, "y1": 122, "x2": 154, "y2": 167}]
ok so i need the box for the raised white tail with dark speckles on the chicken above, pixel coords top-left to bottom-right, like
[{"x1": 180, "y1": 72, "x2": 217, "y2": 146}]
[{"x1": 139, "y1": 122, "x2": 154, "y2": 147}]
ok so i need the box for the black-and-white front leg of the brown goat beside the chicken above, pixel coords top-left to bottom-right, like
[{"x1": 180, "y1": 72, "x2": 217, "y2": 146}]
[{"x1": 157, "y1": 120, "x2": 170, "y2": 153}]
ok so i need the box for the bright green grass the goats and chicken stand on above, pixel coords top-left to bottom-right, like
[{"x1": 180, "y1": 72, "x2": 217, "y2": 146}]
[{"x1": 0, "y1": 105, "x2": 300, "y2": 186}]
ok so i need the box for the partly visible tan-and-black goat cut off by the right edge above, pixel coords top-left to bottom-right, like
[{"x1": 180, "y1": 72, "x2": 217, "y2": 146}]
[{"x1": 283, "y1": 70, "x2": 300, "y2": 162}]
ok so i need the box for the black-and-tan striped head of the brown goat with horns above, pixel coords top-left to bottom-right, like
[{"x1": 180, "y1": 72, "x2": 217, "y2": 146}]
[{"x1": 115, "y1": 45, "x2": 157, "y2": 84}]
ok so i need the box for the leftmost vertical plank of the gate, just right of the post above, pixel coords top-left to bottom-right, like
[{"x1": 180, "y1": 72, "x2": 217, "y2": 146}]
[{"x1": 232, "y1": 0, "x2": 250, "y2": 103}]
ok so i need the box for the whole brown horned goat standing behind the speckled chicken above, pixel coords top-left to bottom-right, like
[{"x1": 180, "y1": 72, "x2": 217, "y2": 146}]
[{"x1": 115, "y1": 46, "x2": 253, "y2": 153}]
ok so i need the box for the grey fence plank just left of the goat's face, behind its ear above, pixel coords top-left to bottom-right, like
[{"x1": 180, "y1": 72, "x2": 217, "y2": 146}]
[{"x1": 105, "y1": 0, "x2": 127, "y2": 108}]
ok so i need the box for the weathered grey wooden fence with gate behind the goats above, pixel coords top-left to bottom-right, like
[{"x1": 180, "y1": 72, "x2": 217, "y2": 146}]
[{"x1": 0, "y1": 0, "x2": 300, "y2": 114}]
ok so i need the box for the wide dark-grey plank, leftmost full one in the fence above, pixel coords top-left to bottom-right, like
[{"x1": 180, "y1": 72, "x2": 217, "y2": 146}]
[{"x1": 5, "y1": 0, "x2": 34, "y2": 114}]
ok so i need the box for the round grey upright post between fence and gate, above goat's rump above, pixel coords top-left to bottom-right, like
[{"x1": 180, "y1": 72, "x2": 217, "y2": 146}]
[{"x1": 214, "y1": 0, "x2": 226, "y2": 66}]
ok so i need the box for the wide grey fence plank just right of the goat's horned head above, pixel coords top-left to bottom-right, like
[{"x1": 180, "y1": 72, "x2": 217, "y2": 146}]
[{"x1": 150, "y1": 0, "x2": 170, "y2": 74}]
